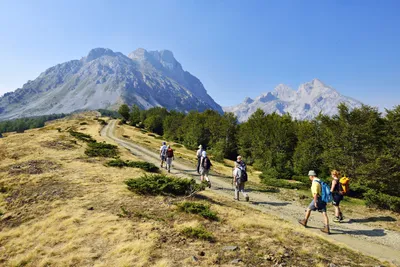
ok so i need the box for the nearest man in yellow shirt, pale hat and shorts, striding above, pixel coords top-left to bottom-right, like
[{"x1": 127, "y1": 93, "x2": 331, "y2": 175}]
[{"x1": 299, "y1": 171, "x2": 330, "y2": 234}]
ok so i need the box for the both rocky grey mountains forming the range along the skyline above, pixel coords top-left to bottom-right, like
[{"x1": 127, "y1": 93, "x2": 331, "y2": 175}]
[{"x1": 0, "y1": 48, "x2": 361, "y2": 122}]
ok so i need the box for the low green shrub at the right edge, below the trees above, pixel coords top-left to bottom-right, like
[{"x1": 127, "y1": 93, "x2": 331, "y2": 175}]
[{"x1": 364, "y1": 190, "x2": 400, "y2": 212}]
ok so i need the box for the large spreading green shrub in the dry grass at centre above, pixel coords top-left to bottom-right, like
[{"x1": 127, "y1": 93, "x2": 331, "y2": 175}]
[{"x1": 125, "y1": 174, "x2": 205, "y2": 196}]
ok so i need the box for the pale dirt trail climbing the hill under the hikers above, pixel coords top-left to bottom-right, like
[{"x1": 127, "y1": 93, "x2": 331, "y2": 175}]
[{"x1": 101, "y1": 120, "x2": 400, "y2": 266}]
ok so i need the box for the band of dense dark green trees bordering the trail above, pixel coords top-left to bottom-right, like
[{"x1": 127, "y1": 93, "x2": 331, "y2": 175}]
[{"x1": 118, "y1": 104, "x2": 400, "y2": 212}]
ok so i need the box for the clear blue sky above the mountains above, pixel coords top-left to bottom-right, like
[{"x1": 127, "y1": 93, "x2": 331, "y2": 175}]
[{"x1": 0, "y1": 0, "x2": 400, "y2": 110}]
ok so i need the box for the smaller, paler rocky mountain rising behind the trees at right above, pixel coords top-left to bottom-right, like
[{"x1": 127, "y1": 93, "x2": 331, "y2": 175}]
[{"x1": 223, "y1": 79, "x2": 362, "y2": 122}]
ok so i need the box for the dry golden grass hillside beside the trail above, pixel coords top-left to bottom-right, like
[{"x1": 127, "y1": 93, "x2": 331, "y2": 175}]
[{"x1": 0, "y1": 115, "x2": 392, "y2": 266}]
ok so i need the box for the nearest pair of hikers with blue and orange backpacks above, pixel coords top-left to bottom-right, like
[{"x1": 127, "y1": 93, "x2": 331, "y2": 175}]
[{"x1": 299, "y1": 170, "x2": 350, "y2": 234}]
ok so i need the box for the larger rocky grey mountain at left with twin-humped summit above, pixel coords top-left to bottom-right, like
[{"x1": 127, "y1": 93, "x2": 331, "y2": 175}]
[{"x1": 0, "y1": 48, "x2": 223, "y2": 120}]
